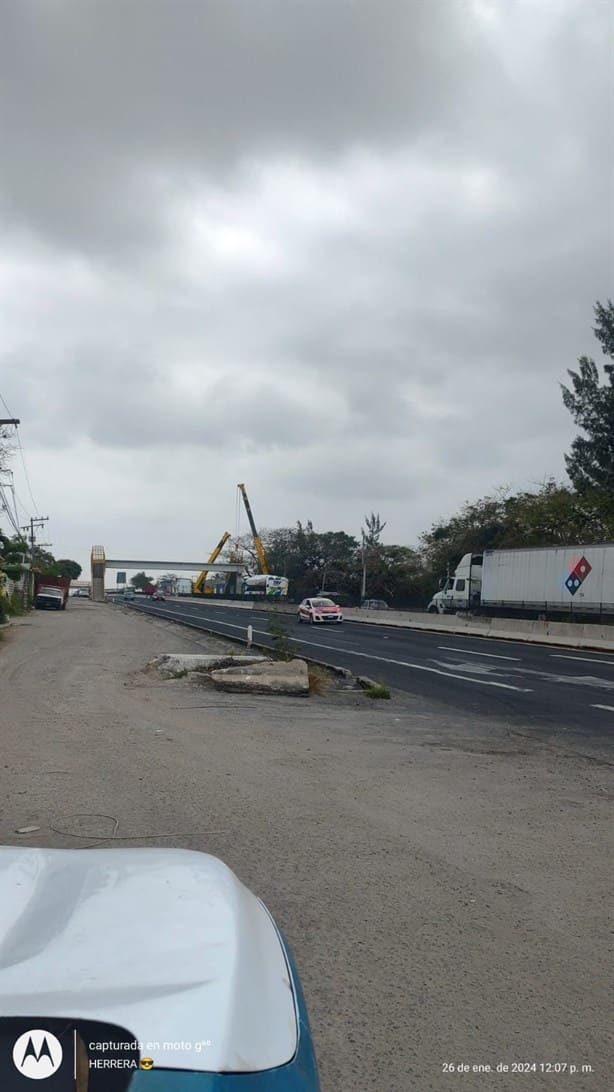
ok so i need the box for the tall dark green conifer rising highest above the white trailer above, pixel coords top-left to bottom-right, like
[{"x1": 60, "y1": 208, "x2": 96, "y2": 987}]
[{"x1": 560, "y1": 299, "x2": 614, "y2": 494}]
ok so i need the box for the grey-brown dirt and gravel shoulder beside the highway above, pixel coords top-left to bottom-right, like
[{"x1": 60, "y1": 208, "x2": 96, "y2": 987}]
[{"x1": 0, "y1": 602, "x2": 614, "y2": 1092}]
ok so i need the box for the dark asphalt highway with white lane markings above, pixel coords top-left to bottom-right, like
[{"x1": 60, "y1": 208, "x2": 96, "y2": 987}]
[{"x1": 125, "y1": 598, "x2": 614, "y2": 736}]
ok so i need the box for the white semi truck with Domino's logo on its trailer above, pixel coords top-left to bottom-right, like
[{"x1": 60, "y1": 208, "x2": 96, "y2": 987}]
[{"x1": 427, "y1": 544, "x2": 614, "y2": 616}]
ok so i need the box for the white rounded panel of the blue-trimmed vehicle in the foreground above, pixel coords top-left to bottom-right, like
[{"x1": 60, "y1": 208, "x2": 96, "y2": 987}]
[{"x1": 0, "y1": 846, "x2": 298, "y2": 1073}]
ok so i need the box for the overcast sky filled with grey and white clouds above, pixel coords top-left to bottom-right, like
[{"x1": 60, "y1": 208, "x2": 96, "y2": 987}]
[{"x1": 0, "y1": 0, "x2": 614, "y2": 565}]
